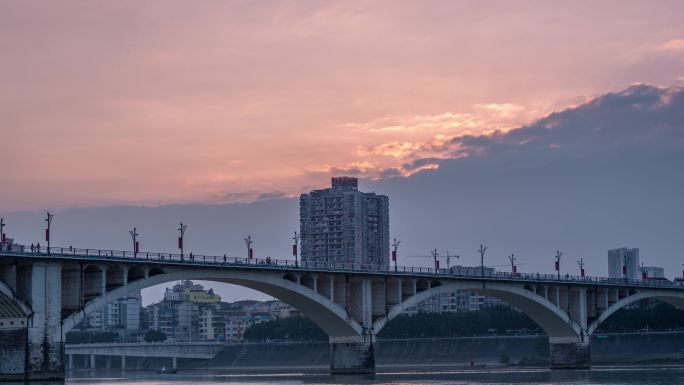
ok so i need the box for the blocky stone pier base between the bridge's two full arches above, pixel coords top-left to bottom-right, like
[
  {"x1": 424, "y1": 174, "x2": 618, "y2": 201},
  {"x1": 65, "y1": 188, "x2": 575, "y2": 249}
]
[{"x1": 330, "y1": 337, "x2": 375, "y2": 374}]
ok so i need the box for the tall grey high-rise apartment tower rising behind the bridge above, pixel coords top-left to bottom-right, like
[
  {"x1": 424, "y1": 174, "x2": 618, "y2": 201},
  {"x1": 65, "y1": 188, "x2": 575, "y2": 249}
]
[{"x1": 299, "y1": 177, "x2": 390, "y2": 268}]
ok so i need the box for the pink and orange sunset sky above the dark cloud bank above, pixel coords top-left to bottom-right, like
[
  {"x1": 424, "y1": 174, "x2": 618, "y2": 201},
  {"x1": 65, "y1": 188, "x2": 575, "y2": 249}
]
[{"x1": 0, "y1": 0, "x2": 684, "y2": 212}]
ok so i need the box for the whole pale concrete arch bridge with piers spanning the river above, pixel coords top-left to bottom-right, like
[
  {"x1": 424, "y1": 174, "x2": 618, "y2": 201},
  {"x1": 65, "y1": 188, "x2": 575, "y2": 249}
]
[{"x1": 0, "y1": 244, "x2": 684, "y2": 380}]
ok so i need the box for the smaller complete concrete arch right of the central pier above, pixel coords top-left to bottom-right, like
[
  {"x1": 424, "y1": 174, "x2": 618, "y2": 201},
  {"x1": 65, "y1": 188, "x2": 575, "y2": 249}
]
[{"x1": 373, "y1": 281, "x2": 581, "y2": 340}]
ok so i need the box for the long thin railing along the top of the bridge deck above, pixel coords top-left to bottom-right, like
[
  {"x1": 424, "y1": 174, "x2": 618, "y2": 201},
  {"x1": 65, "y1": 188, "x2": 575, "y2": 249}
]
[{"x1": 0, "y1": 244, "x2": 684, "y2": 288}]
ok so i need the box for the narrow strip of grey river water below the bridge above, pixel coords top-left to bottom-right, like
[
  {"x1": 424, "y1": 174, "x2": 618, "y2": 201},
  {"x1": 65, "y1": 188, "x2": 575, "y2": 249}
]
[{"x1": 24, "y1": 366, "x2": 684, "y2": 385}]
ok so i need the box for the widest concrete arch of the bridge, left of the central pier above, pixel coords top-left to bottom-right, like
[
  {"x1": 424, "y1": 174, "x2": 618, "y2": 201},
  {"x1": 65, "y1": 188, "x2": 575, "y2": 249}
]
[{"x1": 62, "y1": 269, "x2": 363, "y2": 338}]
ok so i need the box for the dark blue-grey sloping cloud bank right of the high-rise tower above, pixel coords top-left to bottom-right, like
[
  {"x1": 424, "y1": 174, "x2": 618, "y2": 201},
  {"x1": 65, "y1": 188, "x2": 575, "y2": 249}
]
[{"x1": 367, "y1": 85, "x2": 684, "y2": 276}]
